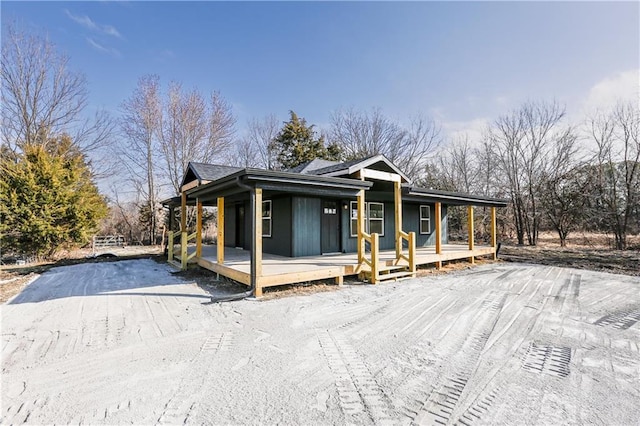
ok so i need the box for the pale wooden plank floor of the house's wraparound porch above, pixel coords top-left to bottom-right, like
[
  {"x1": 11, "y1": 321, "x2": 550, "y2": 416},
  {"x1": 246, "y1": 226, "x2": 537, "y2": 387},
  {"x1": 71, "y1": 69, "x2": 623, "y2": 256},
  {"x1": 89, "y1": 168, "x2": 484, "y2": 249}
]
[{"x1": 194, "y1": 244, "x2": 494, "y2": 287}]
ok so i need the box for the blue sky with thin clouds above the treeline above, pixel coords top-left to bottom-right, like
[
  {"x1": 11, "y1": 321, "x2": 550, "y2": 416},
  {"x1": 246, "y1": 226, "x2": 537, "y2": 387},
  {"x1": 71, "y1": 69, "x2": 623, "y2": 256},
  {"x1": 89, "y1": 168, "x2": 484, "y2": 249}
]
[{"x1": 0, "y1": 1, "x2": 640, "y2": 141}]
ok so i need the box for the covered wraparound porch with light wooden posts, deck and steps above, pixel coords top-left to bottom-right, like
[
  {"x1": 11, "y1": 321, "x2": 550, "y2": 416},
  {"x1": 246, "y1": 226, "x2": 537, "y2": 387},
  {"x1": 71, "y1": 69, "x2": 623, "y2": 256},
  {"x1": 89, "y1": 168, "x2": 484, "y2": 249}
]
[{"x1": 165, "y1": 161, "x2": 500, "y2": 297}]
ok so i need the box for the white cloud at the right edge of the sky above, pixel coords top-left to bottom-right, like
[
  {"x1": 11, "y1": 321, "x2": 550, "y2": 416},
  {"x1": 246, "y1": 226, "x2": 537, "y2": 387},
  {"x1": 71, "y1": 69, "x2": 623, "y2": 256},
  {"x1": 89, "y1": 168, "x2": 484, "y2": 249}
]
[{"x1": 582, "y1": 69, "x2": 640, "y2": 114}]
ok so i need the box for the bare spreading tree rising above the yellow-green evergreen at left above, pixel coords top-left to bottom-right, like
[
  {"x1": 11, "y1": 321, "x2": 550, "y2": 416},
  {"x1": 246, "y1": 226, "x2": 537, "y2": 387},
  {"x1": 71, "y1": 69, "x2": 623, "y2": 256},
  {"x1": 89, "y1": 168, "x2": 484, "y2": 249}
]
[{"x1": 1, "y1": 25, "x2": 114, "y2": 166}]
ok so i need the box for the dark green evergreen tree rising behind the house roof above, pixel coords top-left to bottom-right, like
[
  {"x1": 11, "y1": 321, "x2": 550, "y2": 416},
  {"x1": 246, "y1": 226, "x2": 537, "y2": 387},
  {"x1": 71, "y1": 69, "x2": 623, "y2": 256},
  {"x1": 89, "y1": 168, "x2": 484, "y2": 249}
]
[{"x1": 269, "y1": 111, "x2": 341, "y2": 170}]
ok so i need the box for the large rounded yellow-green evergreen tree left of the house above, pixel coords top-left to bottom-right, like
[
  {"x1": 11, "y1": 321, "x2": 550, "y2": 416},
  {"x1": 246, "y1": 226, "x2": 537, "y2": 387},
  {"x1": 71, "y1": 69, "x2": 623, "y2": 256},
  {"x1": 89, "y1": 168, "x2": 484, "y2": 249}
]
[{"x1": 0, "y1": 136, "x2": 107, "y2": 257}]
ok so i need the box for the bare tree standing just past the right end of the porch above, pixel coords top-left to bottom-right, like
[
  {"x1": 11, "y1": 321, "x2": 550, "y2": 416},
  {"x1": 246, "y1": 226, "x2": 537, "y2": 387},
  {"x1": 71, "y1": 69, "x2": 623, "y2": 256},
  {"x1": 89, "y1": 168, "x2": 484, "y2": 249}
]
[{"x1": 489, "y1": 102, "x2": 566, "y2": 245}]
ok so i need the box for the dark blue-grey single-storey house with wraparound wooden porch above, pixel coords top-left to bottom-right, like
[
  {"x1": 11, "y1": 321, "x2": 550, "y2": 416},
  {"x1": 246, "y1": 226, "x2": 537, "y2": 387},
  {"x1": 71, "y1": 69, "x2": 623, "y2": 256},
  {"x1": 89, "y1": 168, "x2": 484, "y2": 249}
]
[{"x1": 163, "y1": 155, "x2": 506, "y2": 296}]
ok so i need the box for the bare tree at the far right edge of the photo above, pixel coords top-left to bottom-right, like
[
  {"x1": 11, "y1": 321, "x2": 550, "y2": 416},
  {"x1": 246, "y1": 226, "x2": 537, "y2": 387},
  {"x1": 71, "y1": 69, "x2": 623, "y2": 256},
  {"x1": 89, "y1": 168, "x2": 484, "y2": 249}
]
[{"x1": 589, "y1": 102, "x2": 640, "y2": 250}]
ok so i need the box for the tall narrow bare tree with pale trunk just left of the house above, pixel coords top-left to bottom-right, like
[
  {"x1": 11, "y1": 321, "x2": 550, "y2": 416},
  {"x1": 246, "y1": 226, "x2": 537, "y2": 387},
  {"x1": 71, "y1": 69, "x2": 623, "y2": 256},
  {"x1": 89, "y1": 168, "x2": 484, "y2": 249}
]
[{"x1": 120, "y1": 75, "x2": 162, "y2": 244}]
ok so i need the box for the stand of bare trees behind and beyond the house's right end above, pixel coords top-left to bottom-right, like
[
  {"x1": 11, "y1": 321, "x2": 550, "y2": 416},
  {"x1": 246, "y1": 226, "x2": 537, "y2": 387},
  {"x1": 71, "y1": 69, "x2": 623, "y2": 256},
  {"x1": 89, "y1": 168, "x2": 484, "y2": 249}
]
[{"x1": 421, "y1": 102, "x2": 640, "y2": 250}]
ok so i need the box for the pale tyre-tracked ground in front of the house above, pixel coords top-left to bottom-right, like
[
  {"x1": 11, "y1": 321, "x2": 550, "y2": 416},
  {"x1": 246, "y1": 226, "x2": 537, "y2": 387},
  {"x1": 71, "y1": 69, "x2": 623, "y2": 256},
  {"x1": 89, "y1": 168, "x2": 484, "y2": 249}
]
[{"x1": 0, "y1": 260, "x2": 640, "y2": 425}]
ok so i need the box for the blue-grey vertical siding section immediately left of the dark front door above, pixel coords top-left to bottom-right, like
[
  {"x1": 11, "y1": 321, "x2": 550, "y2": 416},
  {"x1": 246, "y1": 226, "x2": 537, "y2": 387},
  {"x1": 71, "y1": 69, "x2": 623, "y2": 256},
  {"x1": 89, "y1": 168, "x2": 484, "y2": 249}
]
[{"x1": 291, "y1": 197, "x2": 322, "y2": 257}]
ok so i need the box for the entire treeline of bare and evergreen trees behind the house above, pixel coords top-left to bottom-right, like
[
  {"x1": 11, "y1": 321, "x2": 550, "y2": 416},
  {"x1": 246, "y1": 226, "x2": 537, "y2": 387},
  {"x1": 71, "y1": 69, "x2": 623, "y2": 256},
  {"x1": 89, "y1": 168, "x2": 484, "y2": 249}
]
[{"x1": 0, "y1": 28, "x2": 640, "y2": 255}]
